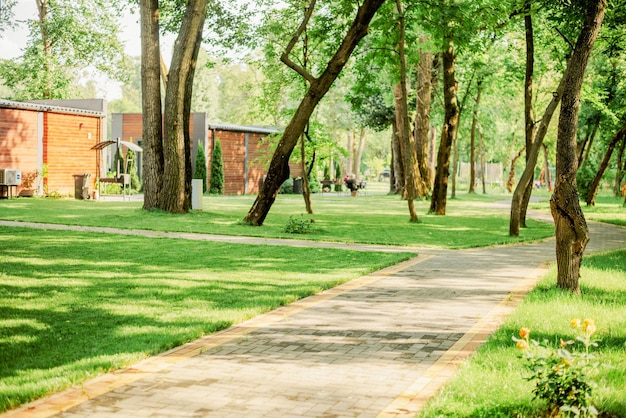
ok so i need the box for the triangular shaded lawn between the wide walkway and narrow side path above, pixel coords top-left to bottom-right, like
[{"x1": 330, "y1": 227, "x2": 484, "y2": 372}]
[{"x1": 0, "y1": 227, "x2": 414, "y2": 411}]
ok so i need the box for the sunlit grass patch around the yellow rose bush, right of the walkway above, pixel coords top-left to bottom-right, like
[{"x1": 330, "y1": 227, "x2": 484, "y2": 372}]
[{"x1": 420, "y1": 249, "x2": 626, "y2": 418}]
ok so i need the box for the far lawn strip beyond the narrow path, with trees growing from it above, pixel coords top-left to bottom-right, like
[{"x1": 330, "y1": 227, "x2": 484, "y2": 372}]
[{"x1": 0, "y1": 186, "x2": 554, "y2": 249}]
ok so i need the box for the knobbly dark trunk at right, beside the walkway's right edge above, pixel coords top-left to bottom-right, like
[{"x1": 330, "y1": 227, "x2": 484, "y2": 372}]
[{"x1": 550, "y1": 0, "x2": 606, "y2": 293}]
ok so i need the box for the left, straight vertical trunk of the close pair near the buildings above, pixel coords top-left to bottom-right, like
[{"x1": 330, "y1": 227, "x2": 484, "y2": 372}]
[{"x1": 140, "y1": 0, "x2": 163, "y2": 210}]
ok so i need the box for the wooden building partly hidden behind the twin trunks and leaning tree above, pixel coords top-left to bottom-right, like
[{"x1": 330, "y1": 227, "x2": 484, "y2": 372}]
[{"x1": 111, "y1": 112, "x2": 302, "y2": 195}]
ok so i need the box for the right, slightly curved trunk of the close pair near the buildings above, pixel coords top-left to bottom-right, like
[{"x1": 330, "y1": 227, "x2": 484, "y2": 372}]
[{"x1": 159, "y1": 0, "x2": 208, "y2": 213}]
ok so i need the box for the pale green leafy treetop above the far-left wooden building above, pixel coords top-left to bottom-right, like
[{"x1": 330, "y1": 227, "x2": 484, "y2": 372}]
[{"x1": 0, "y1": 0, "x2": 127, "y2": 100}]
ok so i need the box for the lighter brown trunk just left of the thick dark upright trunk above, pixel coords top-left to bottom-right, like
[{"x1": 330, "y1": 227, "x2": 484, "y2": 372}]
[{"x1": 415, "y1": 42, "x2": 433, "y2": 191}]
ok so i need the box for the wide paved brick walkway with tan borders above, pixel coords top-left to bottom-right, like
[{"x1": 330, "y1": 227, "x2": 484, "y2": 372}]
[{"x1": 2, "y1": 214, "x2": 626, "y2": 418}]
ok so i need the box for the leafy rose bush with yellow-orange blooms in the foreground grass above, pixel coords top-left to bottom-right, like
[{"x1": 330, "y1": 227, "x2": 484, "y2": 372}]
[{"x1": 513, "y1": 319, "x2": 598, "y2": 417}]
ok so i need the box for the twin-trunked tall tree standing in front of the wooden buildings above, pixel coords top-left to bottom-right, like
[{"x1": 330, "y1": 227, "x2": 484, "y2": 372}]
[{"x1": 140, "y1": 0, "x2": 208, "y2": 213}]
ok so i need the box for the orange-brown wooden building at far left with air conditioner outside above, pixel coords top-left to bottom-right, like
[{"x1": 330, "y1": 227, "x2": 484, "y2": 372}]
[{"x1": 0, "y1": 100, "x2": 106, "y2": 195}]
